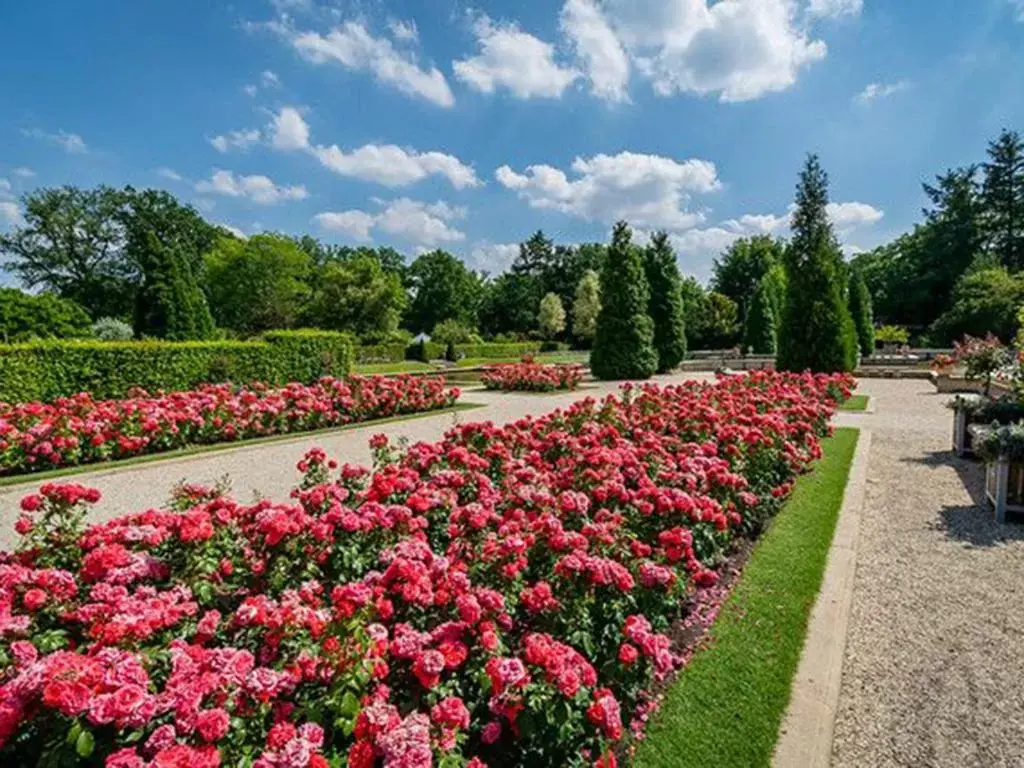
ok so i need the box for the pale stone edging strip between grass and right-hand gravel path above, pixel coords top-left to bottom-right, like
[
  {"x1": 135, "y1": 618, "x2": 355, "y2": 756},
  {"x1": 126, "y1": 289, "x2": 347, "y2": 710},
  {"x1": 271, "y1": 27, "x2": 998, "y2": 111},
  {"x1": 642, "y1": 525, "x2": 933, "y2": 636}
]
[{"x1": 772, "y1": 428, "x2": 871, "y2": 768}]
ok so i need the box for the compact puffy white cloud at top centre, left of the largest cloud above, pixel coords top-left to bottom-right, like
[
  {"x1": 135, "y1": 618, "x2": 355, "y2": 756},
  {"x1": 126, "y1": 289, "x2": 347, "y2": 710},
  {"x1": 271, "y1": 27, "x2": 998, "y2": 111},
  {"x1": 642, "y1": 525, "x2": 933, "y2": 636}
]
[{"x1": 452, "y1": 15, "x2": 580, "y2": 98}]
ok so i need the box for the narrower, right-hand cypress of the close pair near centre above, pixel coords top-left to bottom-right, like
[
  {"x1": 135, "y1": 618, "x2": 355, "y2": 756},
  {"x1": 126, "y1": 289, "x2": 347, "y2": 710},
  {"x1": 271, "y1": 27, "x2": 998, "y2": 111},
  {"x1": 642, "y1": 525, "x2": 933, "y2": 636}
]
[{"x1": 644, "y1": 232, "x2": 686, "y2": 374}]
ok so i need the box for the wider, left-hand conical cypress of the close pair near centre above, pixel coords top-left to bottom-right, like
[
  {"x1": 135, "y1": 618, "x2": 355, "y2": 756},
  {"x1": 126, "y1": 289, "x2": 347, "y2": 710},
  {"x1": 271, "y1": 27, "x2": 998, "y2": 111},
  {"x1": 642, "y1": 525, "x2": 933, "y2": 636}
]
[{"x1": 590, "y1": 221, "x2": 657, "y2": 379}]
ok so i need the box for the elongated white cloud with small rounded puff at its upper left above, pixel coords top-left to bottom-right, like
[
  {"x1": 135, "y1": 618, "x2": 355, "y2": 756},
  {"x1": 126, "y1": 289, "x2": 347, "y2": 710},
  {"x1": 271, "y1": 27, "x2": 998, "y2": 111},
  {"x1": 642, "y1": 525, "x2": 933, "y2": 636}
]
[{"x1": 270, "y1": 106, "x2": 480, "y2": 189}]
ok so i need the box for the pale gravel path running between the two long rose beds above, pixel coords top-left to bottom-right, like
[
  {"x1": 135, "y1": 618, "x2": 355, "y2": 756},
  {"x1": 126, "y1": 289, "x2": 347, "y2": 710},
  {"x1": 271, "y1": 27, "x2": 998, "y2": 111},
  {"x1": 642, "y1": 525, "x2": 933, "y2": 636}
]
[{"x1": 0, "y1": 374, "x2": 709, "y2": 550}]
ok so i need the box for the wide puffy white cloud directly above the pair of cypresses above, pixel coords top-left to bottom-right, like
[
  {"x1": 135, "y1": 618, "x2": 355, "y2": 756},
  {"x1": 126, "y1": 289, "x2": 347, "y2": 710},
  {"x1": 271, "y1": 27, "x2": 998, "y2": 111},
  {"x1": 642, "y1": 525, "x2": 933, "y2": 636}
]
[{"x1": 495, "y1": 152, "x2": 720, "y2": 230}]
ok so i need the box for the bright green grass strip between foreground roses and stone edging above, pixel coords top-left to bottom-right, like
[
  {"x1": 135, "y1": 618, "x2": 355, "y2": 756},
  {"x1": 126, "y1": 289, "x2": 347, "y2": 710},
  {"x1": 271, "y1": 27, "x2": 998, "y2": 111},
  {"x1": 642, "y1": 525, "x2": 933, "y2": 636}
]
[{"x1": 633, "y1": 428, "x2": 859, "y2": 768}]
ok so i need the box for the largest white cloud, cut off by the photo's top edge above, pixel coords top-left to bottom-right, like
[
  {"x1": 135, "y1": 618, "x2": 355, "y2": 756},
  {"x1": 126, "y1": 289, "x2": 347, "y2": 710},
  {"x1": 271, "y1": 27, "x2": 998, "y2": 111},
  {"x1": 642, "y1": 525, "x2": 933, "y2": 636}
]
[{"x1": 605, "y1": 0, "x2": 835, "y2": 101}]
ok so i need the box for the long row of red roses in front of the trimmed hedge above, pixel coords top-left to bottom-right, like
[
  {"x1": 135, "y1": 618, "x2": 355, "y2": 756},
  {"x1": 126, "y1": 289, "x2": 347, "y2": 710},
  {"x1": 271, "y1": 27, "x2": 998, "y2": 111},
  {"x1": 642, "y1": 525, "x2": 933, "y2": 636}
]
[{"x1": 0, "y1": 376, "x2": 459, "y2": 475}]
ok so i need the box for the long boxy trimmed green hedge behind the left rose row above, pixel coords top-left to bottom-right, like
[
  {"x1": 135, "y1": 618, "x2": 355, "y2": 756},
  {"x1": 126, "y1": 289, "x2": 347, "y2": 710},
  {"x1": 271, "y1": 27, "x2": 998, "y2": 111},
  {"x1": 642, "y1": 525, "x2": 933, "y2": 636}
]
[{"x1": 0, "y1": 331, "x2": 354, "y2": 402}]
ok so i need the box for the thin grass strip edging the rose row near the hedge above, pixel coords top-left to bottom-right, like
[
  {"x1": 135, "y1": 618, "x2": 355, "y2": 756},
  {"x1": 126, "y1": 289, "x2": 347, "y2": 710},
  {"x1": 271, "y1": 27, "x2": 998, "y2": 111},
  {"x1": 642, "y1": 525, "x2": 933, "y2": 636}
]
[{"x1": 0, "y1": 402, "x2": 484, "y2": 488}]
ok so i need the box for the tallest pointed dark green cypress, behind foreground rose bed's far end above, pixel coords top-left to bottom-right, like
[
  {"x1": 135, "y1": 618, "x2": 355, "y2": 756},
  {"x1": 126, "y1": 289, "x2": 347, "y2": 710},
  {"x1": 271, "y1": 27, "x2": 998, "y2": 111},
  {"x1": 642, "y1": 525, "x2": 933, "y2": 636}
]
[{"x1": 776, "y1": 155, "x2": 857, "y2": 373}]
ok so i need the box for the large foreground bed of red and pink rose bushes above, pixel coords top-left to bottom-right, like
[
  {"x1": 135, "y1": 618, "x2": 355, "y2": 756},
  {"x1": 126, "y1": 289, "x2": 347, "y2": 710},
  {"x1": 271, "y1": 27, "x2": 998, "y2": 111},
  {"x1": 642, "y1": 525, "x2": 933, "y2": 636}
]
[{"x1": 0, "y1": 373, "x2": 851, "y2": 768}]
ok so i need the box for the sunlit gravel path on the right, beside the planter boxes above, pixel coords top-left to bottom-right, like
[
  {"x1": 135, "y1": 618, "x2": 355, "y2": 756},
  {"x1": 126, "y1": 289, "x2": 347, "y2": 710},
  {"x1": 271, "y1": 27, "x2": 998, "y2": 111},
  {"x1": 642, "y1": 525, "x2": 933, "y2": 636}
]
[{"x1": 833, "y1": 380, "x2": 1024, "y2": 768}]
